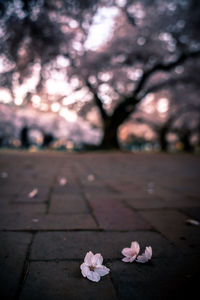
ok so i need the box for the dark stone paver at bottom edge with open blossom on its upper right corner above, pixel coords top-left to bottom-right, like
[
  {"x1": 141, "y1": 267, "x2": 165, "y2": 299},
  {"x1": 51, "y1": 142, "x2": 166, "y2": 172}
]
[{"x1": 20, "y1": 261, "x2": 117, "y2": 300}]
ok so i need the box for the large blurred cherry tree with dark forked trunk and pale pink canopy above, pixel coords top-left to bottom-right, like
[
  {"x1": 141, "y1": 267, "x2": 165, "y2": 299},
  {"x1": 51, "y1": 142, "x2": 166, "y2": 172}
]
[{"x1": 0, "y1": 0, "x2": 200, "y2": 149}]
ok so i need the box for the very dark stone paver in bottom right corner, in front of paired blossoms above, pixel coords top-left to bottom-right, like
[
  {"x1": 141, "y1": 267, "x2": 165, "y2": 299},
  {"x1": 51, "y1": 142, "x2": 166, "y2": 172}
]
[{"x1": 110, "y1": 256, "x2": 200, "y2": 300}]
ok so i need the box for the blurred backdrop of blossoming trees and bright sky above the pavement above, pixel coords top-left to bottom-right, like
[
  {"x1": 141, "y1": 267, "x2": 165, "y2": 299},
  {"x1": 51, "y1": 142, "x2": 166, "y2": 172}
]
[{"x1": 0, "y1": 0, "x2": 200, "y2": 151}]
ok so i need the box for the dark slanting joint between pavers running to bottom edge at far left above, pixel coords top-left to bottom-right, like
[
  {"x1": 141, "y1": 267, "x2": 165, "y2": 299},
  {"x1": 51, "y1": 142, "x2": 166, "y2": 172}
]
[{"x1": 15, "y1": 233, "x2": 35, "y2": 300}]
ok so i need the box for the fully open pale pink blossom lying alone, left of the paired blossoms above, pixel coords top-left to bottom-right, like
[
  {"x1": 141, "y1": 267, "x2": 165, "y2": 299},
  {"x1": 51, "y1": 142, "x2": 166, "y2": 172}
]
[{"x1": 80, "y1": 251, "x2": 110, "y2": 282}]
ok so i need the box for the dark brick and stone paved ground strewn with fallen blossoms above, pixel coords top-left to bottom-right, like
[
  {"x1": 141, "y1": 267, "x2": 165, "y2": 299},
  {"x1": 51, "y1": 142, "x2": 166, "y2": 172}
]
[{"x1": 0, "y1": 152, "x2": 200, "y2": 300}]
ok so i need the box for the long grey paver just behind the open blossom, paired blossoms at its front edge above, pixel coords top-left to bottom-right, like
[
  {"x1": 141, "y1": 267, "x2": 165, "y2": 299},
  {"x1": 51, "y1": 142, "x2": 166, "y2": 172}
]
[{"x1": 31, "y1": 231, "x2": 179, "y2": 260}]
